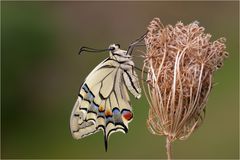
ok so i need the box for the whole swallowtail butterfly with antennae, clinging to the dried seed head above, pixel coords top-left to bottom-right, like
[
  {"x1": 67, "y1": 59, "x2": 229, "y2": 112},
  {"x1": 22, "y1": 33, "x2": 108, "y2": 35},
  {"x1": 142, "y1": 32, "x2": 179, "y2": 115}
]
[{"x1": 70, "y1": 34, "x2": 146, "y2": 151}]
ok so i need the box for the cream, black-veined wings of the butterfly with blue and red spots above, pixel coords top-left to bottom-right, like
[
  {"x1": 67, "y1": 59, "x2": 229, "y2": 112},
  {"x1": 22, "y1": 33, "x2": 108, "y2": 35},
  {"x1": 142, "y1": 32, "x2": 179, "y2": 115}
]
[{"x1": 70, "y1": 59, "x2": 133, "y2": 149}]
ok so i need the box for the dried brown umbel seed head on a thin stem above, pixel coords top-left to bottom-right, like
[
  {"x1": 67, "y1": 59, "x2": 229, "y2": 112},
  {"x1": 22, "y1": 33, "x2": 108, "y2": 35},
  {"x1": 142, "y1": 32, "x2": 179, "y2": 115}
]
[{"x1": 143, "y1": 18, "x2": 228, "y2": 158}]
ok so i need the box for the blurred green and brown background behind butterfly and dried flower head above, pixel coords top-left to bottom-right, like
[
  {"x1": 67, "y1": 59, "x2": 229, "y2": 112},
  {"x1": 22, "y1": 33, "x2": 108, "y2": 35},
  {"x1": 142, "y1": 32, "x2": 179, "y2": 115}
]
[{"x1": 1, "y1": 1, "x2": 239, "y2": 159}]
